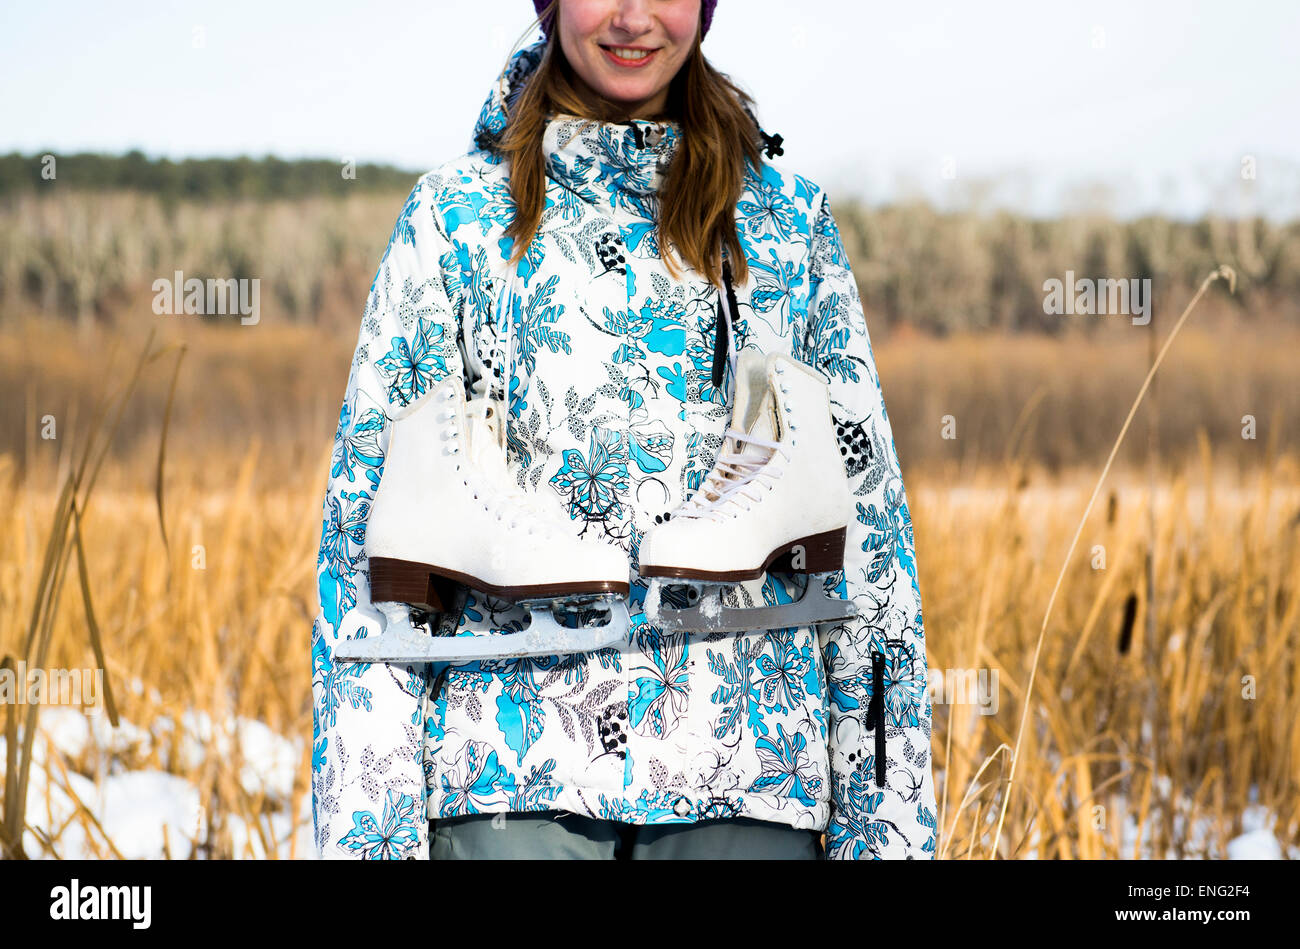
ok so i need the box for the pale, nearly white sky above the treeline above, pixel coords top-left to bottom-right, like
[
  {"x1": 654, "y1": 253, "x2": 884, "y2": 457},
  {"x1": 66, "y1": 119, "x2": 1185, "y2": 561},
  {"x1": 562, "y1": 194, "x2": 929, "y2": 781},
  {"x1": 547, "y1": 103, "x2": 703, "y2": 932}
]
[{"x1": 0, "y1": 0, "x2": 1300, "y2": 216}]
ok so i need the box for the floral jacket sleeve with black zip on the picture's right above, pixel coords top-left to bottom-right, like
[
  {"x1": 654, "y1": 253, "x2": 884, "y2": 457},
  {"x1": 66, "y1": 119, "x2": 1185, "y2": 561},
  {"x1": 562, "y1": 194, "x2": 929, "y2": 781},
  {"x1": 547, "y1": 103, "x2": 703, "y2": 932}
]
[{"x1": 805, "y1": 191, "x2": 937, "y2": 859}]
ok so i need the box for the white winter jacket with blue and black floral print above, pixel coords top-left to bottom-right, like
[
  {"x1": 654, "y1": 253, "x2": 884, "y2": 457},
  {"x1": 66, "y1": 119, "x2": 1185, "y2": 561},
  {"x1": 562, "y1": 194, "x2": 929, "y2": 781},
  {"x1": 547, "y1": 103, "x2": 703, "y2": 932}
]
[{"x1": 312, "y1": 43, "x2": 936, "y2": 858}]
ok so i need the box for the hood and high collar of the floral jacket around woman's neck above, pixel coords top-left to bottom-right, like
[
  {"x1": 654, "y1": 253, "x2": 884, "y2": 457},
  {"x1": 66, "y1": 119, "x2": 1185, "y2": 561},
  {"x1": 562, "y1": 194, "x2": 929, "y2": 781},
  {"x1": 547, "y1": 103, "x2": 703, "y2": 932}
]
[{"x1": 472, "y1": 39, "x2": 781, "y2": 221}]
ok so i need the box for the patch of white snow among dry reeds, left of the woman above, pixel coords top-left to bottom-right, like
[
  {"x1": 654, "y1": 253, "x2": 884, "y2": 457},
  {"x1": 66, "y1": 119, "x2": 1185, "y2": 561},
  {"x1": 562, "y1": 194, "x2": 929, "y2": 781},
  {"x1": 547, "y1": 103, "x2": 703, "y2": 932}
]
[{"x1": 0, "y1": 707, "x2": 315, "y2": 859}]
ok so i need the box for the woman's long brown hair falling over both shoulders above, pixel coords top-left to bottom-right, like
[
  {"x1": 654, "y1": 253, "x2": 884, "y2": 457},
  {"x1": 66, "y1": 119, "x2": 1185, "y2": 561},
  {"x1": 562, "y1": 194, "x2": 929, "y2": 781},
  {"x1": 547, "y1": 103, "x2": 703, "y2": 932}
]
[{"x1": 498, "y1": 0, "x2": 762, "y2": 286}]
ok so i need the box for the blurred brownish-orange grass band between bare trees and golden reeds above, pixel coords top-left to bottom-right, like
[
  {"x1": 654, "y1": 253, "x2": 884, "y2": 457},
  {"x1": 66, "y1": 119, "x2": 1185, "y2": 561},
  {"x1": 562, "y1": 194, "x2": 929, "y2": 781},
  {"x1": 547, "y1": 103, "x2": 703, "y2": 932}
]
[{"x1": 0, "y1": 318, "x2": 1300, "y2": 488}]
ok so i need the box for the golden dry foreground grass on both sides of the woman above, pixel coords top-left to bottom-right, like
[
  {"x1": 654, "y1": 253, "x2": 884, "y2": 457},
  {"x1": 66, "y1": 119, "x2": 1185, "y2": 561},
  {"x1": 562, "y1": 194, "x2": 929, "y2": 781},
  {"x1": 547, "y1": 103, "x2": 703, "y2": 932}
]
[{"x1": 0, "y1": 447, "x2": 1300, "y2": 858}]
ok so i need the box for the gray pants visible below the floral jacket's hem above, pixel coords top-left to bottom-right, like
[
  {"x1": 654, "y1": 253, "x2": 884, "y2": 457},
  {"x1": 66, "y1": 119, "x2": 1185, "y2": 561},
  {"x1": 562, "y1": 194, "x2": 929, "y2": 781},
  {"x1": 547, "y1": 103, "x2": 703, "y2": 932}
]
[{"x1": 429, "y1": 811, "x2": 822, "y2": 861}]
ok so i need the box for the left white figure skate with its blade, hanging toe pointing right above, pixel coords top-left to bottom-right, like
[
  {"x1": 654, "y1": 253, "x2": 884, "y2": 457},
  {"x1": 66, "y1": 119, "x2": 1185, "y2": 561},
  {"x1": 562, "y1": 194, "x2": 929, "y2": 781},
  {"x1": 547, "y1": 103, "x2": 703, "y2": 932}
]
[{"x1": 334, "y1": 366, "x2": 631, "y2": 663}]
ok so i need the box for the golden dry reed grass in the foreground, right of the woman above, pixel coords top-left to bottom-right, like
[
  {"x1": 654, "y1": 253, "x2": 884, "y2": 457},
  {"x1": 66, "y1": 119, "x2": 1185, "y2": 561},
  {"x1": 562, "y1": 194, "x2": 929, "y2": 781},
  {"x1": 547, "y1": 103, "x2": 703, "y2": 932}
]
[{"x1": 925, "y1": 451, "x2": 1300, "y2": 858}]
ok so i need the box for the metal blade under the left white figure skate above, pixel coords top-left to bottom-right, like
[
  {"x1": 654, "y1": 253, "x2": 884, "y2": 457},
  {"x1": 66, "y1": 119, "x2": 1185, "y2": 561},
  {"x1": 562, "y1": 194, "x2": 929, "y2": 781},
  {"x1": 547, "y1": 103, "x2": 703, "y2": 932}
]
[{"x1": 334, "y1": 597, "x2": 631, "y2": 663}]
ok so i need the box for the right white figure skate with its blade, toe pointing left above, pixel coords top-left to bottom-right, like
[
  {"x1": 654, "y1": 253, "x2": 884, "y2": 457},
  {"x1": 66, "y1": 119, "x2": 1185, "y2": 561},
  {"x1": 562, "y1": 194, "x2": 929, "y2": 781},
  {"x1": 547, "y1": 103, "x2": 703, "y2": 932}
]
[{"x1": 640, "y1": 348, "x2": 855, "y2": 632}]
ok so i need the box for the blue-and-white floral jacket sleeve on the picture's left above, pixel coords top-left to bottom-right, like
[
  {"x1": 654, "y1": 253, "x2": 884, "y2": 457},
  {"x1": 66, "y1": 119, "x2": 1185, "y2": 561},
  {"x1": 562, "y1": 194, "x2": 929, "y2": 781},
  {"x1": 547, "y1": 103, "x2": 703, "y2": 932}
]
[{"x1": 312, "y1": 171, "x2": 464, "y2": 859}]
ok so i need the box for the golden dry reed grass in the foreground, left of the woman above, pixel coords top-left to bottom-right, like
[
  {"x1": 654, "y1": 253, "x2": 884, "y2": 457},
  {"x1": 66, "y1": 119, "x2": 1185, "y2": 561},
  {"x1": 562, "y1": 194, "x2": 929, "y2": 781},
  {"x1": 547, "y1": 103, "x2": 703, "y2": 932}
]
[{"x1": 0, "y1": 445, "x2": 324, "y2": 857}]
